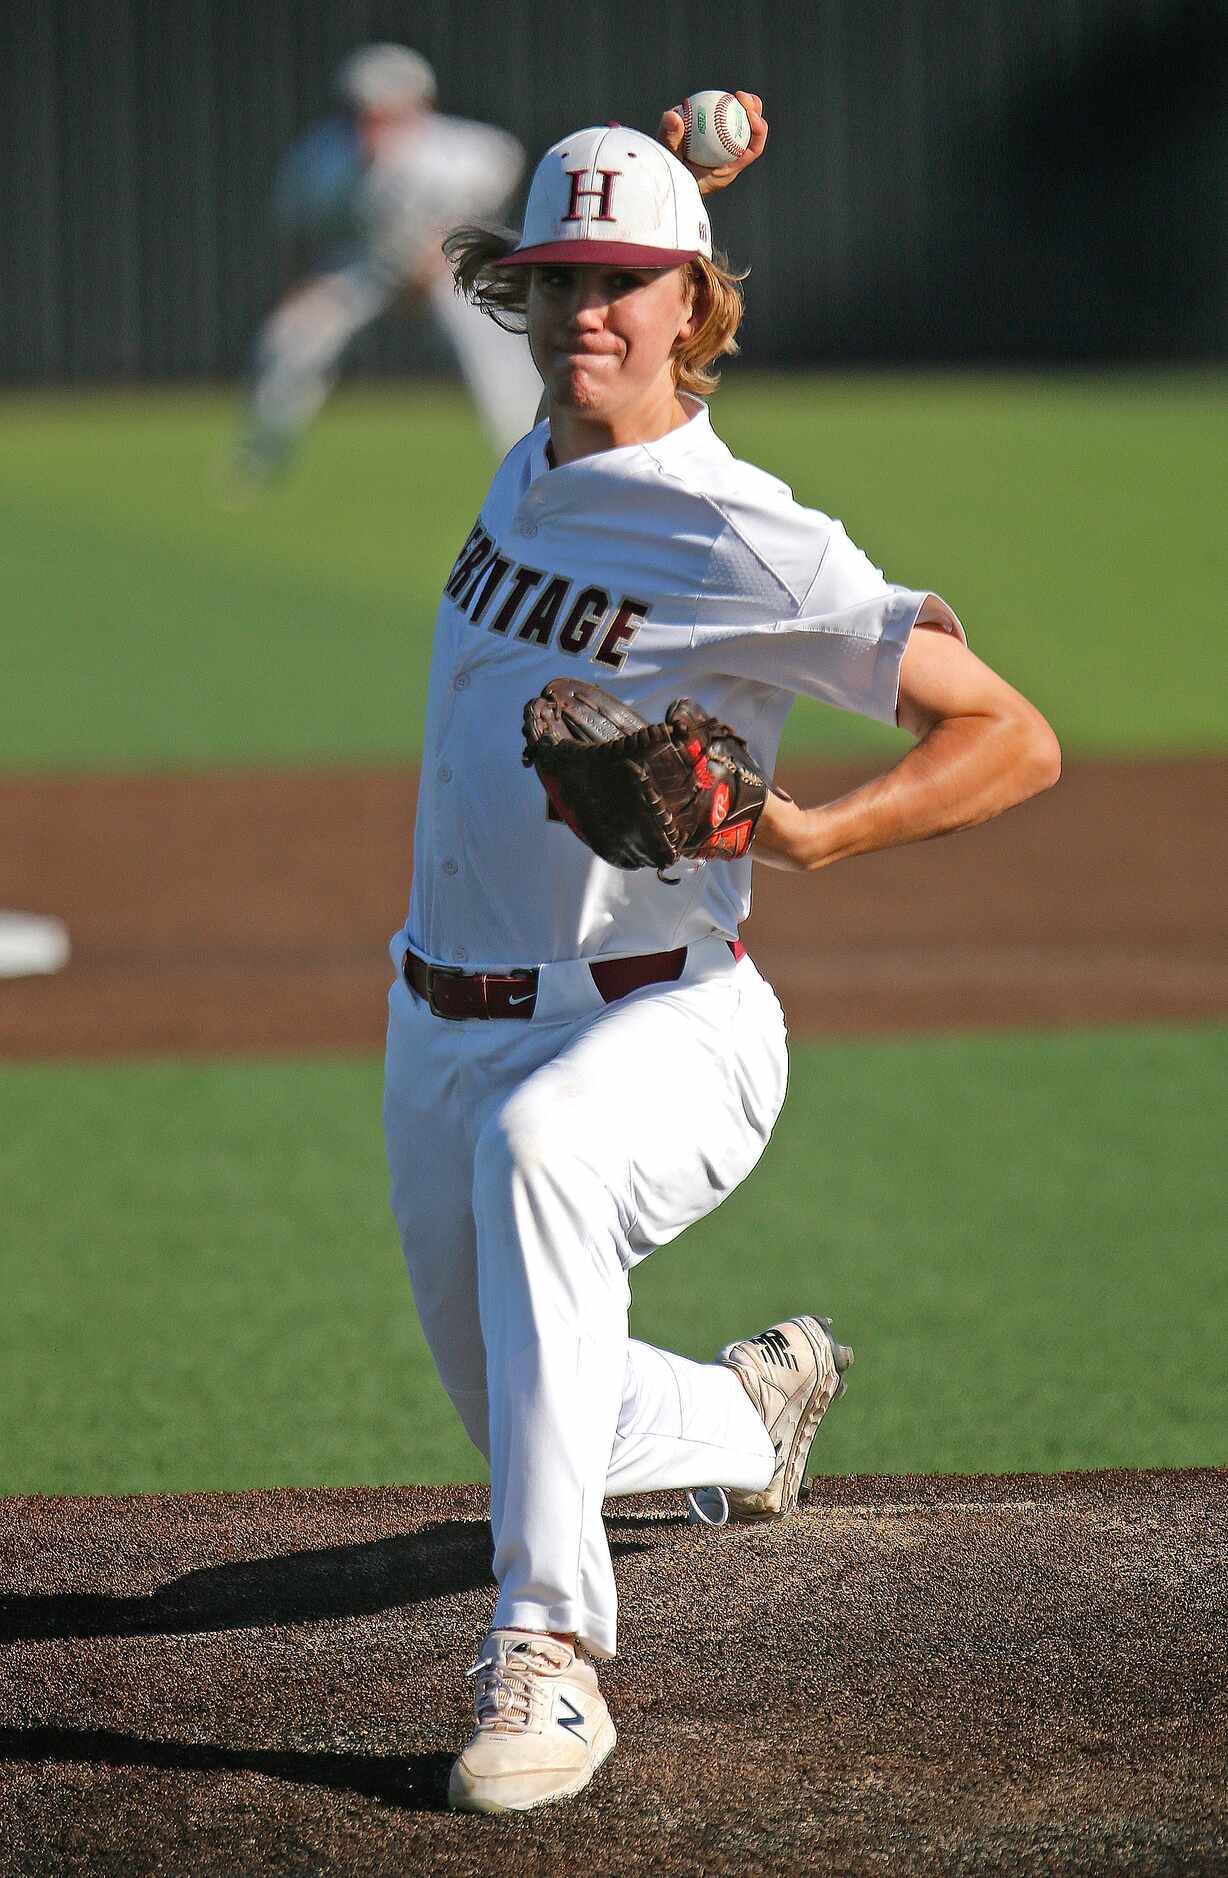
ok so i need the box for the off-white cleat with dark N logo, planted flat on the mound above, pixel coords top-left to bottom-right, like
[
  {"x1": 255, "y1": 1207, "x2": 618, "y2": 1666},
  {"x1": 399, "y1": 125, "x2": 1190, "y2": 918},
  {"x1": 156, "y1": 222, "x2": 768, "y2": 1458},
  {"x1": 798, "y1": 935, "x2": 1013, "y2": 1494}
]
[{"x1": 447, "y1": 1630, "x2": 616, "y2": 1812}]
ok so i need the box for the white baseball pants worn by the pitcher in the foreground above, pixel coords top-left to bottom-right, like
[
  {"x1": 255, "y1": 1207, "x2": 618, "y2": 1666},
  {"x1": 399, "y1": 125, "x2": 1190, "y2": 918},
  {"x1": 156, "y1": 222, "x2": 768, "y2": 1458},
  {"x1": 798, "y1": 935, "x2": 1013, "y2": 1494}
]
[{"x1": 385, "y1": 939, "x2": 787, "y2": 1656}]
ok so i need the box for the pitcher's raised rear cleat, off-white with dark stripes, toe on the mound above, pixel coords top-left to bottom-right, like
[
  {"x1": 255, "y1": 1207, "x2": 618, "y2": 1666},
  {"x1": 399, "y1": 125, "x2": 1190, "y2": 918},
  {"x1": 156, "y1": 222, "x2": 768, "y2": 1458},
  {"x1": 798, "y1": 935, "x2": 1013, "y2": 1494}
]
[{"x1": 706, "y1": 1316, "x2": 852, "y2": 1525}]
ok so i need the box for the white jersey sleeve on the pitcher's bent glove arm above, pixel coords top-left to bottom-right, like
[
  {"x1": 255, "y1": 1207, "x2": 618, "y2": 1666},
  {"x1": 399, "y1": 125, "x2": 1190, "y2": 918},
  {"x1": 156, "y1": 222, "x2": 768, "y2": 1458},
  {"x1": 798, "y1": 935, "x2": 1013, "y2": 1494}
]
[{"x1": 697, "y1": 511, "x2": 965, "y2": 723}]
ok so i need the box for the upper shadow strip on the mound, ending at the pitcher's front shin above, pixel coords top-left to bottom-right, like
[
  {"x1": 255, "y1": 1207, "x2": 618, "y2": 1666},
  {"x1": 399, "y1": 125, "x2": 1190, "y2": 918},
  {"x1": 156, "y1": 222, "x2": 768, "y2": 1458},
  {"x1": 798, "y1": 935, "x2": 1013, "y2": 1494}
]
[{"x1": 0, "y1": 1519, "x2": 490, "y2": 1643}]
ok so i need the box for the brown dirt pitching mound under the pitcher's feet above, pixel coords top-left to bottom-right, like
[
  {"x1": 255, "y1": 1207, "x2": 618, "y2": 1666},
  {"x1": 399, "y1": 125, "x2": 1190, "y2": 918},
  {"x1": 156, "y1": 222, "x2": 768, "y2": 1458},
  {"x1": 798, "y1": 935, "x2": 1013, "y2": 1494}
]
[{"x1": 0, "y1": 1469, "x2": 1228, "y2": 1878}]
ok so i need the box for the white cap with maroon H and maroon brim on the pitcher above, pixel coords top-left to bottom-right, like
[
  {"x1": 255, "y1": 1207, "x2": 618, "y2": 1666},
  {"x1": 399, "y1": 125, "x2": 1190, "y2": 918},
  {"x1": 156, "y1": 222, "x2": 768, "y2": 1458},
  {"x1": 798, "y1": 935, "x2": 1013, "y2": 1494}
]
[{"x1": 496, "y1": 124, "x2": 712, "y2": 267}]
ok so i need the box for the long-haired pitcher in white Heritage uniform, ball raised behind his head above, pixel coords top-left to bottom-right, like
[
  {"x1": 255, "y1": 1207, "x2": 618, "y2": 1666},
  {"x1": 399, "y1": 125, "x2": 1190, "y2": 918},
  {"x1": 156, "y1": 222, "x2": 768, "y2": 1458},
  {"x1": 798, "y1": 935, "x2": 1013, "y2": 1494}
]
[{"x1": 385, "y1": 92, "x2": 1059, "y2": 1812}]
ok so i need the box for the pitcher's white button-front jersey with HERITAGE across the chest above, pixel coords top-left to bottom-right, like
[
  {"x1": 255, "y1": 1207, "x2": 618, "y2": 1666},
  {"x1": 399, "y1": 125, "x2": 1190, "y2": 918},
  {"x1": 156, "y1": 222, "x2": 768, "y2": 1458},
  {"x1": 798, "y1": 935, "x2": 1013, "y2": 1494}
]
[{"x1": 392, "y1": 398, "x2": 961, "y2": 971}]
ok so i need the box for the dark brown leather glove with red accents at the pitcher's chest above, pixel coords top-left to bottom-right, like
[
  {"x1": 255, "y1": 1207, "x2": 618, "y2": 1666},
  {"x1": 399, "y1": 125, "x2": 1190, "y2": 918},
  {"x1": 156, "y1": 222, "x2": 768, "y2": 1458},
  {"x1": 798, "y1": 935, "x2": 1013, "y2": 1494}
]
[{"x1": 524, "y1": 678, "x2": 772, "y2": 868}]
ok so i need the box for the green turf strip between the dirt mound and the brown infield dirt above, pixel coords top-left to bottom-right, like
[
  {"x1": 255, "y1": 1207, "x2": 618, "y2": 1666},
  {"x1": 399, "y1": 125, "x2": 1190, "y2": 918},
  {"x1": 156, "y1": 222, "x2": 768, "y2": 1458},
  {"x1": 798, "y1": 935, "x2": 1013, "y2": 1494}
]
[{"x1": 0, "y1": 1029, "x2": 1228, "y2": 1493}]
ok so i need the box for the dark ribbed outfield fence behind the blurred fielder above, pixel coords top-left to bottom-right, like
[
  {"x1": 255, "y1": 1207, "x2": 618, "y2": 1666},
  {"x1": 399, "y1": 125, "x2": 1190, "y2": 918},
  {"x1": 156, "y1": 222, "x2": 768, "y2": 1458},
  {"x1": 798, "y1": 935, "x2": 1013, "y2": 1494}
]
[{"x1": 0, "y1": 0, "x2": 1228, "y2": 383}]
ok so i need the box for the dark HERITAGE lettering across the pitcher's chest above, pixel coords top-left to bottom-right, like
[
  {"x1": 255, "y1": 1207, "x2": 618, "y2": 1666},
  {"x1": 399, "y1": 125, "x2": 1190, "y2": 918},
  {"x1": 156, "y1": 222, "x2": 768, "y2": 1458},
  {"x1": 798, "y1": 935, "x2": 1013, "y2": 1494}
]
[{"x1": 443, "y1": 522, "x2": 652, "y2": 670}]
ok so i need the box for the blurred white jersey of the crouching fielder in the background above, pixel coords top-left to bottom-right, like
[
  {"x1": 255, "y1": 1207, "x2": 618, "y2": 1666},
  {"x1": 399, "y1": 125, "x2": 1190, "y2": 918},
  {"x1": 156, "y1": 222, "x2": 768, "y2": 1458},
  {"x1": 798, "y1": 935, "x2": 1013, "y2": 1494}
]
[{"x1": 274, "y1": 113, "x2": 524, "y2": 282}]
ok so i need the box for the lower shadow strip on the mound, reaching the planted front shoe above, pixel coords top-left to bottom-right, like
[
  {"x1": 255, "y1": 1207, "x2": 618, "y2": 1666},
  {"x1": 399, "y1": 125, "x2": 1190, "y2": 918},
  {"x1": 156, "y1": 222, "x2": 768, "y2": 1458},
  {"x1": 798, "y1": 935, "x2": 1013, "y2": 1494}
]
[{"x1": 0, "y1": 1728, "x2": 453, "y2": 1812}]
